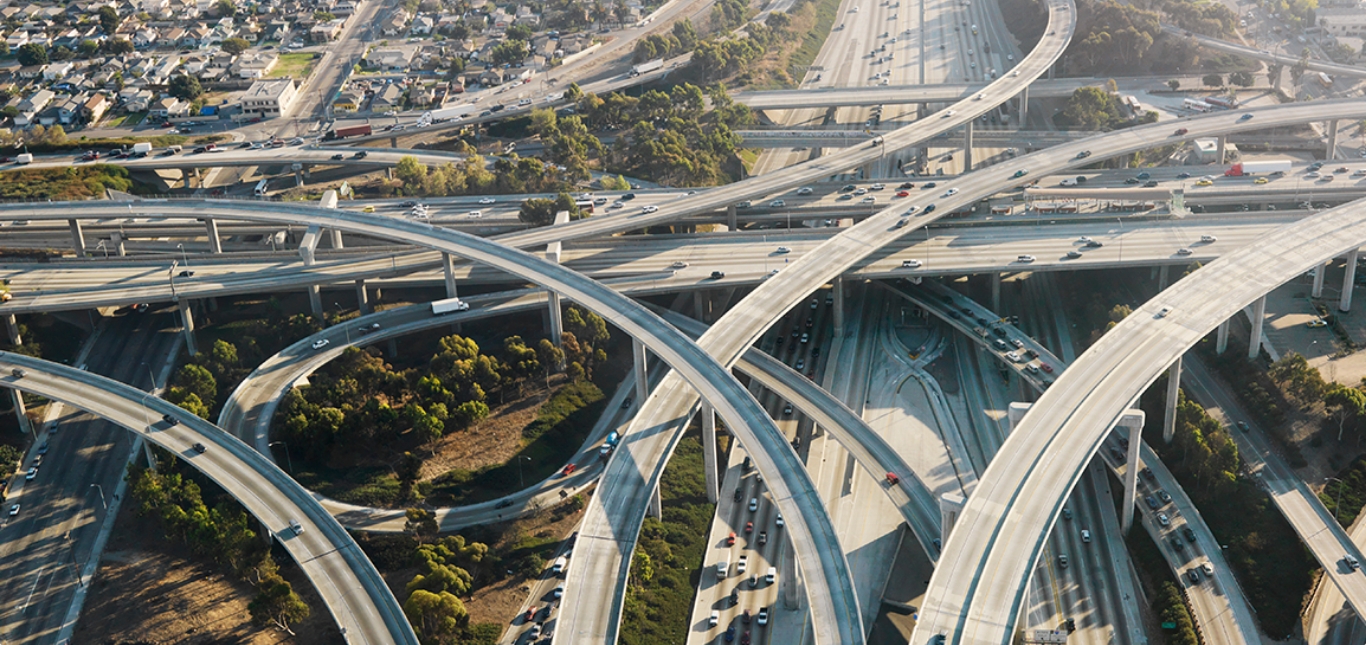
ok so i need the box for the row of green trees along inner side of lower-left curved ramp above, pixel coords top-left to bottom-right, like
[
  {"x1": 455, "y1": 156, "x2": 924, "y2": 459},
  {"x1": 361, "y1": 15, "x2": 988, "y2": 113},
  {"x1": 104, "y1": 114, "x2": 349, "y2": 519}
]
[{"x1": 127, "y1": 459, "x2": 310, "y2": 634}]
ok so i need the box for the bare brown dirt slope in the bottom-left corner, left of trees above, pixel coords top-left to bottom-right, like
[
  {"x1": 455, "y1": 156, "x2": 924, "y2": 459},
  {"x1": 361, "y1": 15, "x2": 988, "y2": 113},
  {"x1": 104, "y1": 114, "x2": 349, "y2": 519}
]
[{"x1": 71, "y1": 504, "x2": 342, "y2": 645}]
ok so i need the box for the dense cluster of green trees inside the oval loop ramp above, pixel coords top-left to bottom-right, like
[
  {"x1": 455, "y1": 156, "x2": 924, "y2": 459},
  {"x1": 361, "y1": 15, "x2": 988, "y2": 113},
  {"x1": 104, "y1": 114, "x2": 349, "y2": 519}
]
[{"x1": 280, "y1": 307, "x2": 609, "y2": 467}]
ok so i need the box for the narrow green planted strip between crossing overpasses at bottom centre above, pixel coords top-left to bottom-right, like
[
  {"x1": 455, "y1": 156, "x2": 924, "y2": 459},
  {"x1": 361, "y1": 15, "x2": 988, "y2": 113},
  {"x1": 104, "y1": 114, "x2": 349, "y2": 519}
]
[{"x1": 620, "y1": 432, "x2": 716, "y2": 645}]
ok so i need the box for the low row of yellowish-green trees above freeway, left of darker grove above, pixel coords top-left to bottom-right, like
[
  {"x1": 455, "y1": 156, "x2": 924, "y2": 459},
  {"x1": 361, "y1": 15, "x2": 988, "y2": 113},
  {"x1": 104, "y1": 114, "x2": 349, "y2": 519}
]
[{"x1": 393, "y1": 154, "x2": 570, "y2": 197}]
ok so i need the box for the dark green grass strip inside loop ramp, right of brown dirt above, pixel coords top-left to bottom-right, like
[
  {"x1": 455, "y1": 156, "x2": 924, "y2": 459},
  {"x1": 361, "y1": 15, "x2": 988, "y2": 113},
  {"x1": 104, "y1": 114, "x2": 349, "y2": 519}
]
[{"x1": 423, "y1": 381, "x2": 607, "y2": 506}]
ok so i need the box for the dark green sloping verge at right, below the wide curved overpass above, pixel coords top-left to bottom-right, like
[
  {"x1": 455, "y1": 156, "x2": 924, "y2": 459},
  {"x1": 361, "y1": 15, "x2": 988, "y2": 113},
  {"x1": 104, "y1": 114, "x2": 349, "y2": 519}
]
[{"x1": 1142, "y1": 380, "x2": 1318, "y2": 640}]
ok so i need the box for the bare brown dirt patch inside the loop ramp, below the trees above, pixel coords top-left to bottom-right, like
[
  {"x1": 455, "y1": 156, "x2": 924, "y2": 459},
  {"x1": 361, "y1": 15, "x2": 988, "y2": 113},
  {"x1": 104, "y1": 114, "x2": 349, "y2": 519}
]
[{"x1": 421, "y1": 374, "x2": 564, "y2": 480}]
